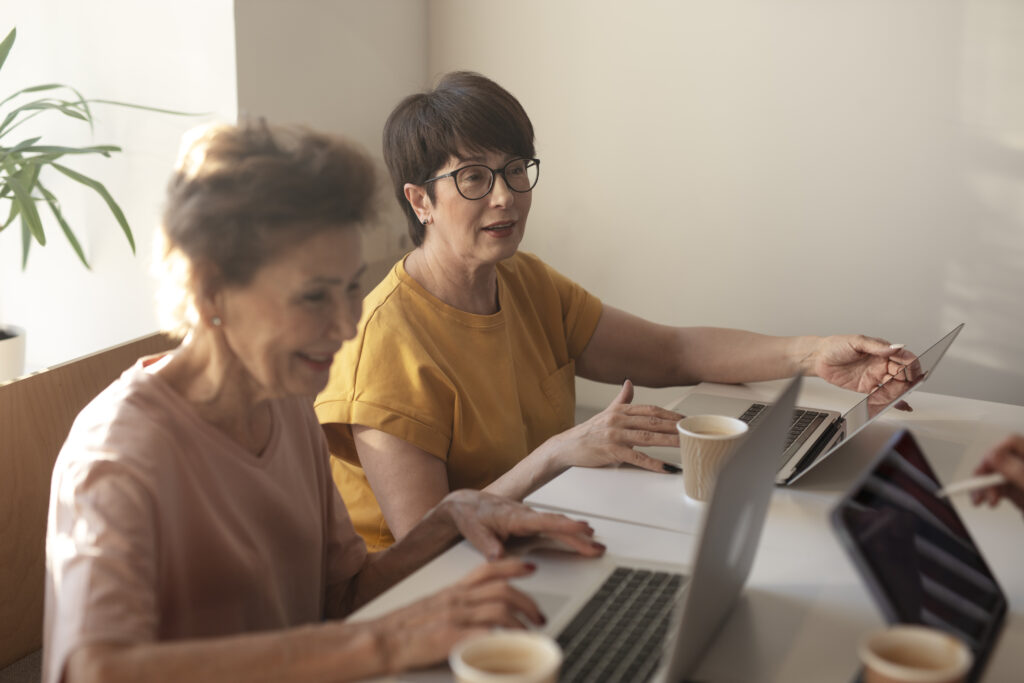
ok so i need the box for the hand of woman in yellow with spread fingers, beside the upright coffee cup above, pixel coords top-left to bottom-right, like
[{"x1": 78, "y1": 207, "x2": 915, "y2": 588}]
[{"x1": 542, "y1": 380, "x2": 683, "y2": 472}]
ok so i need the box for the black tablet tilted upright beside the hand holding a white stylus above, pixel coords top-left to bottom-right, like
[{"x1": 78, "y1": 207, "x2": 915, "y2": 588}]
[{"x1": 831, "y1": 429, "x2": 1007, "y2": 681}]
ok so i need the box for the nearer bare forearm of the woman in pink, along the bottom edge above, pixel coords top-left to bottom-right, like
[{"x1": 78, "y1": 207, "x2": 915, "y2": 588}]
[{"x1": 65, "y1": 623, "x2": 389, "y2": 683}]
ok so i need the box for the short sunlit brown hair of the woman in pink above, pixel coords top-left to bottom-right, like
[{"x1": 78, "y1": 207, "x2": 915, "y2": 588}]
[{"x1": 158, "y1": 120, "x2": 376, "y2": 331}]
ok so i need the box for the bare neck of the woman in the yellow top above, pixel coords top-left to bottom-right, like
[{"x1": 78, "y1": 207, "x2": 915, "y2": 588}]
[{"x1": 406, "y1": 246, "x2": 500, "y2": 315}]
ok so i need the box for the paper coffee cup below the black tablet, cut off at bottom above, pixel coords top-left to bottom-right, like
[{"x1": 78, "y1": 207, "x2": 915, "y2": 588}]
[{"x1": 857, "y1": 625, "x2": 974, "y2": 683}]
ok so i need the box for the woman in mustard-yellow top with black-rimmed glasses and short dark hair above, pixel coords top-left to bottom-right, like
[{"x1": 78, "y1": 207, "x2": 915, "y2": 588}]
[{"x1": 316, "y1": 72, "x2": 909, "y2": 548}]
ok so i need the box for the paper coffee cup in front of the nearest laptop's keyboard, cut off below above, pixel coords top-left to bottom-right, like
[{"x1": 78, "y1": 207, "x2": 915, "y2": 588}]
[{"x1": 449, "y1": 630, "x2": 562, "y2": 683}]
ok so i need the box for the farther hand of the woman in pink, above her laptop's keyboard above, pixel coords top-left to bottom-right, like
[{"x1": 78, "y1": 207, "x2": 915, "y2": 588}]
[{"x1": 441, "y1": 489, "x2": 604, "y2": 560}]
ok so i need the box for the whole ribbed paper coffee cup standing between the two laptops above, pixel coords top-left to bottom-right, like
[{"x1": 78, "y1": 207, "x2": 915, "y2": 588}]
[{"x1": 676, "y1": 415, "x2": 748, "y2": 501}]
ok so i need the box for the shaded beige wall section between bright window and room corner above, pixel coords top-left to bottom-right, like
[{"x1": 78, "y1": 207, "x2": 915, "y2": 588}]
[{"x1": 236, "y1": 0, "x2": 427, "y2": 272}]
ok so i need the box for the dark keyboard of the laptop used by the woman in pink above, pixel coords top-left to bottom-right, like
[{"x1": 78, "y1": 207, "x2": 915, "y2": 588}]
[{"x1": 558, "y1": 567, "x2": 686, "y2": 683}]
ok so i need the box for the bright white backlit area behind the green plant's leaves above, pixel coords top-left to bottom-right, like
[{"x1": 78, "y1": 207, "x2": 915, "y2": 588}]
[{"x1": 0, "y1": 0, "x2": 236, "y2": 370}]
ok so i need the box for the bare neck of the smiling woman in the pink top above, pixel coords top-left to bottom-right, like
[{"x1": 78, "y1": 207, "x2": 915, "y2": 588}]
[{"x1": 157, "y1": 330, "x2": 272, "y2": 456}]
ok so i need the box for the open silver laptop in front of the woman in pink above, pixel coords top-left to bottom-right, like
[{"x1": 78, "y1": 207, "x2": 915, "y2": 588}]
[{"x1": 516, "y1": 376, "x2": 801, "y2": 683}]
